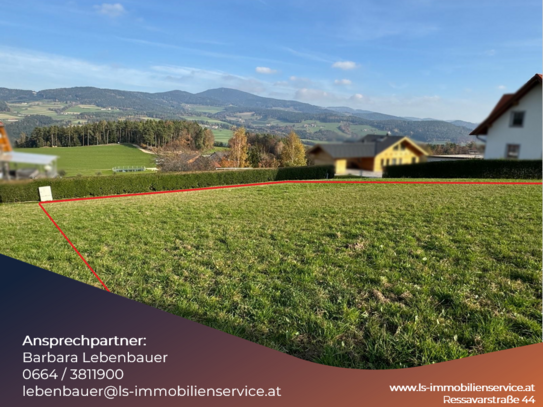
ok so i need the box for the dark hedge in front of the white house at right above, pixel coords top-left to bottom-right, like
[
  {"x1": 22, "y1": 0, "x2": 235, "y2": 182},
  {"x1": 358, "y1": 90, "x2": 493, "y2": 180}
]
[{"x1": 383, "y1": 159, "x2": 542, "y2": 179}]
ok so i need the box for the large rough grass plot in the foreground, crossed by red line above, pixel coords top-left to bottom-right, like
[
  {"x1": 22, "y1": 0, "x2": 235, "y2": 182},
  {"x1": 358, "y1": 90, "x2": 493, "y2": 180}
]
[{"x1": 0, "y1": 184, "x2": 542, "y2": 369}]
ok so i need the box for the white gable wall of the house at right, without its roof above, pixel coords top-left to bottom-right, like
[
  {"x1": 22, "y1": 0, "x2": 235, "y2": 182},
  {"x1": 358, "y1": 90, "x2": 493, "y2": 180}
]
[{"x1": 485, "y1": 85, "x2": 543, "y2": 160}]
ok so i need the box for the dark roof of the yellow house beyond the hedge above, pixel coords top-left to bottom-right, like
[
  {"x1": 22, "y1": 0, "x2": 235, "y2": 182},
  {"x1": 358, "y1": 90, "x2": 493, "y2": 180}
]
[{"x1": 308, "y1": 134, "x2": 424, "y2": 158}]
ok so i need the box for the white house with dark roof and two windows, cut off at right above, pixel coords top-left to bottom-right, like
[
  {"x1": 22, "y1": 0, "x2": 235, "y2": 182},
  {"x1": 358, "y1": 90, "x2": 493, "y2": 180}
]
[{"x1": 470, "y1": 74, "x2": 543, "y2": 160}]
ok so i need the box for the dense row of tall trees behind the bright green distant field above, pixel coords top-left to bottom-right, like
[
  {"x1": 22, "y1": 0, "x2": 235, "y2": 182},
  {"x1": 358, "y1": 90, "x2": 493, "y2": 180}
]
[{"x1": 15, "y1": 120, "x2": 215, "y2": 151}]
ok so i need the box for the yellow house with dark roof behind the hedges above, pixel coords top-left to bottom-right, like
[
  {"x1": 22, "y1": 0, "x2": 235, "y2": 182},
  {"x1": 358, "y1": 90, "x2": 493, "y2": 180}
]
[{"x1": 307, "y1": 134, "x2": 427, "y2": 174}]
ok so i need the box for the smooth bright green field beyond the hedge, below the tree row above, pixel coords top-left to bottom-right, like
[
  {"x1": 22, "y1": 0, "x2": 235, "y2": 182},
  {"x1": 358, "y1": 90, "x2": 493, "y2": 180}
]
[{"x1": 15, "y1": 144, "x2": 156, "y2": 177}]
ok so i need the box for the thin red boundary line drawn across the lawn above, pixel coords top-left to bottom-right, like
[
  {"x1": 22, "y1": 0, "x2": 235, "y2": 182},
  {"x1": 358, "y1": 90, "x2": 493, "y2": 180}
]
[{"x1": 39, "y1": 181, "x2": 542, "y2": 292}]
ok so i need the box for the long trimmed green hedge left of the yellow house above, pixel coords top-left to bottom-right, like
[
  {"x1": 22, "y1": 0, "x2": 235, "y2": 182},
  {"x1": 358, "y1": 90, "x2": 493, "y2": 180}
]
[{"x1": 0, "y1": 166, "x2": 334, "y2": 203}]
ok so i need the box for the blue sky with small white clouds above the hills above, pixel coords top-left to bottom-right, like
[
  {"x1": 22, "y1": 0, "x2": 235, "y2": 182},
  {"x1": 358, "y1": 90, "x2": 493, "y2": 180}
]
[{"x1": 0, "y1": 0, "x2": 542, "y2": 122}]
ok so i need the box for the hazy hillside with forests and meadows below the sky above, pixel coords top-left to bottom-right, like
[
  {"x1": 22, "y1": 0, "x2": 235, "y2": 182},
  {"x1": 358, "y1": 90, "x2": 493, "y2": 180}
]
[{"x1": 0, "y1": 87, "x2": 480, "y2": 143}]
